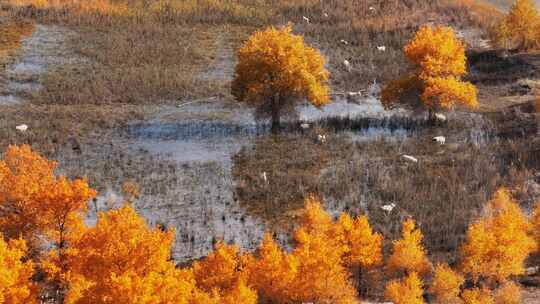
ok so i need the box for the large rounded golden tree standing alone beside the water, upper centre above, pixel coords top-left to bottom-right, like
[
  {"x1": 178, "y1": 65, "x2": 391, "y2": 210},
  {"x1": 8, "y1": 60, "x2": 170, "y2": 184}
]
[{"x1": 232, "y1": 26, "x2": 329, "y2": 131}]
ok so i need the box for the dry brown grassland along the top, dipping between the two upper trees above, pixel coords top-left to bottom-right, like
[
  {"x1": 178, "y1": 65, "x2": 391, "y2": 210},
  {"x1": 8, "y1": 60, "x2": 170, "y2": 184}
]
[{"x1": 1, "y1": 0, "x2": 506, "y2": 104}]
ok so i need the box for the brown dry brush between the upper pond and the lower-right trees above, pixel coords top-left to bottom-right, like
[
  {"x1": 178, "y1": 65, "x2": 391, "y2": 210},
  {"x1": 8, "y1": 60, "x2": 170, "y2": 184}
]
[{"x1": 233, "y1": 127, "x2": 540, "y2": 262}]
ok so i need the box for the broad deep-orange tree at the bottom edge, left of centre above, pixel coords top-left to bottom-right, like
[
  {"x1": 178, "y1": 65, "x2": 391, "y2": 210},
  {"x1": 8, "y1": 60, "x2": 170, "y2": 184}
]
[{"x1": 42, "y1": 205, "x2": 195, "y2": 304}]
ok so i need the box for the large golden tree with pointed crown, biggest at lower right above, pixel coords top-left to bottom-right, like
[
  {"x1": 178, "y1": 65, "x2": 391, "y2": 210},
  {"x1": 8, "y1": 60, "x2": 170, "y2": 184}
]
[{"x1": 461, "y1": 188, "x2": 536, "y2": 282}]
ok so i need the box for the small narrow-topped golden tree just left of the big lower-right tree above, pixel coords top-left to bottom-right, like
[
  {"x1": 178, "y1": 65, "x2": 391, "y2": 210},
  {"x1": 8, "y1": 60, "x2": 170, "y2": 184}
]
[{"x1": 387, "y1": 219, "x2": 431, "y2": 274}]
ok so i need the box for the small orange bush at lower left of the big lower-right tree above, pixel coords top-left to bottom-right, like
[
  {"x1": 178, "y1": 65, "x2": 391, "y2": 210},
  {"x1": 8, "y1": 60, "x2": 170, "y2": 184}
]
[{"x1": 430, "y1": 264, "x2": 465, "y2": 304}]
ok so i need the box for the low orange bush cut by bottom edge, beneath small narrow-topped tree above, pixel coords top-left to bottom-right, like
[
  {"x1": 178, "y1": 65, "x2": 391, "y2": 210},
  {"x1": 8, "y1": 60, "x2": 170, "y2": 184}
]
[{"x1": 384, "y1": 271, "x2": 424, "y2": 304}]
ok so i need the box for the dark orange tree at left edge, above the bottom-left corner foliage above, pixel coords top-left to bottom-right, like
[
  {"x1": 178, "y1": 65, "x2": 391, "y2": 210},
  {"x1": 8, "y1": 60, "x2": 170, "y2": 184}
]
[{"x1": 0, "y1": 145, "x2": 96, "y2": 247}]
